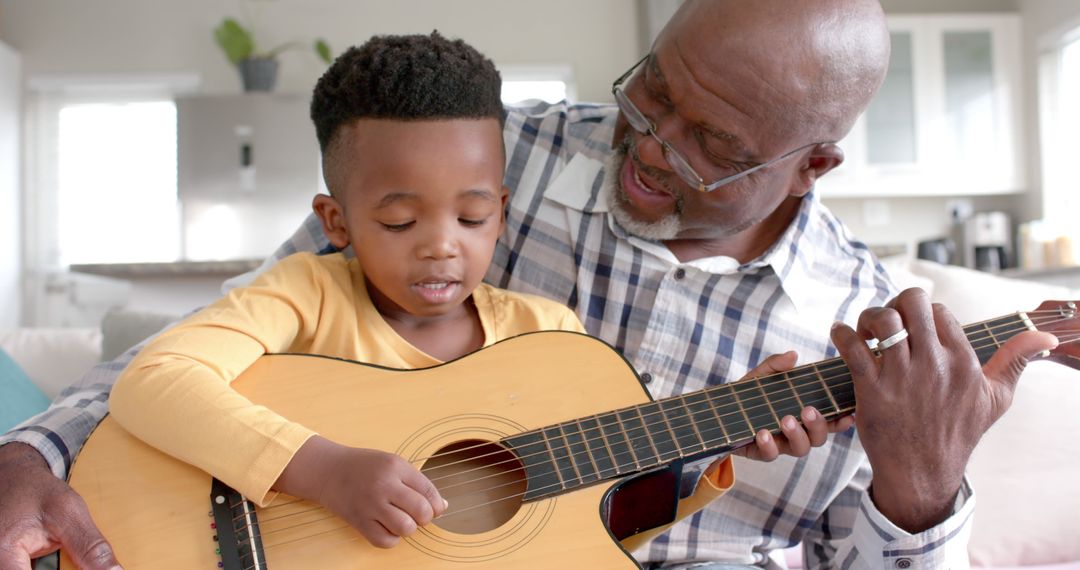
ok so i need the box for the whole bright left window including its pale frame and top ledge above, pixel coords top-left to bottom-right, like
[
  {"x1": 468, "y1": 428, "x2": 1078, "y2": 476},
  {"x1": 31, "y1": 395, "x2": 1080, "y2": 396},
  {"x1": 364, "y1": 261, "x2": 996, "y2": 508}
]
[{"x1": 26, "y1": 77, "x2": 198, "y2": 272}]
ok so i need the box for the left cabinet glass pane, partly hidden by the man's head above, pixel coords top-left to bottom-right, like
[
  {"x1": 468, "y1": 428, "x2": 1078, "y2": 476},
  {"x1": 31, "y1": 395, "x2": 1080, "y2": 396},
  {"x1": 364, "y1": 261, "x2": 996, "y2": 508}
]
[{"x1": 866, "y1": 31, "x2": 916, "y2": 164}]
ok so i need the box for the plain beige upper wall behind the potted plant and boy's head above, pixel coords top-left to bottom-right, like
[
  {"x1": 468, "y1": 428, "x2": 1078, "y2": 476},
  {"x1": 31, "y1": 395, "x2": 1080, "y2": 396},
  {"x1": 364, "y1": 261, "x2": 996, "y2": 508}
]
[{"x1": 0, "y1": 0, "x2": 640, "y2": 100}]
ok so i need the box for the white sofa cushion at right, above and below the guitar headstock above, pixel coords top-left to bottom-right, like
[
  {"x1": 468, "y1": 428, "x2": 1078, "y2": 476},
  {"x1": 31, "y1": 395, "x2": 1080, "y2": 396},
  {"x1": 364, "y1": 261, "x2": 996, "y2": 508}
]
[{"x1": 889, "y1": 260, "x2": 1080, "y2": 567}]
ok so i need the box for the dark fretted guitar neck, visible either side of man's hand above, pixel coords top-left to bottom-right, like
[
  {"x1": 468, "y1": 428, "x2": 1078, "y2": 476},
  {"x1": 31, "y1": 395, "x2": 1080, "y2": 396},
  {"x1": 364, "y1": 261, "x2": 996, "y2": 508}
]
[{"x1": 502, "y1": 312, "x2": 1035, "y2": 500}]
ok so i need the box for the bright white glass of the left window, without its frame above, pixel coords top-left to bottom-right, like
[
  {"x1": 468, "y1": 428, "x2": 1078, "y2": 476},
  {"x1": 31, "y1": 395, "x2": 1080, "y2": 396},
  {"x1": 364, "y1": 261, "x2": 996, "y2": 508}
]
[{"x1": 56, "y1": 100, "x2": 180, "y2": 267}]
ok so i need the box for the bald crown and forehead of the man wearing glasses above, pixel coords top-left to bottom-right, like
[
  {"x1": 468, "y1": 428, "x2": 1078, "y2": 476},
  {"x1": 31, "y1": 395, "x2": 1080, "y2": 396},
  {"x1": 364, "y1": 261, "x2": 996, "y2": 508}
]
[{"x1": 657, "y1": 0, "x2": 889, "y2": 141}]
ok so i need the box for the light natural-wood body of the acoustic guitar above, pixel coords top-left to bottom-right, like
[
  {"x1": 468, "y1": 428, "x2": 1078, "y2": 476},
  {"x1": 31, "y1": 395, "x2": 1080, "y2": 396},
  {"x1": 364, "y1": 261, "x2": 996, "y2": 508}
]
[{"x1": 62, "y1": 333, "x2": 666, "y2": 570}]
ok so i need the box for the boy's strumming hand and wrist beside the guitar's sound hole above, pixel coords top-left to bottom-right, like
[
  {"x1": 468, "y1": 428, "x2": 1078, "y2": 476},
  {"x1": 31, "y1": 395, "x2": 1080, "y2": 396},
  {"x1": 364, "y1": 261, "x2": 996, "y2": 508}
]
[{"x1": 274, "y1": 435, "x2": 447, "y2": 548}]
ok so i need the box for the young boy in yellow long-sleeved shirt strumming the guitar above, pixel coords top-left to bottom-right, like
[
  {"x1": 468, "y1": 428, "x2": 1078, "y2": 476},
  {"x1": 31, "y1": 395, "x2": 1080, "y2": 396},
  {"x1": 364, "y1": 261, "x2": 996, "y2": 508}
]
[{"x1": 109, "y1": 32, "x2": 583, "y2": 547}]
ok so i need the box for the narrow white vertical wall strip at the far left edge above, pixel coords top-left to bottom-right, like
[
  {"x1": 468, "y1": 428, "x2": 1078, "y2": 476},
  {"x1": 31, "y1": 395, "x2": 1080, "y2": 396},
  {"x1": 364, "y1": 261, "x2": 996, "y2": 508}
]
[{"x1": 0, "y1": 42, "x2": 23, "y2": 330}]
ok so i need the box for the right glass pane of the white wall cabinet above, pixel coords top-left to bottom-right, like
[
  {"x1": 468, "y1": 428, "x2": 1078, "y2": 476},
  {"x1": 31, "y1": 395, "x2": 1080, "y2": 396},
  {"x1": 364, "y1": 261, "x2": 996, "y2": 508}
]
[{"x1": 944, "y1": 30, "x2": 998, "y2": 162}]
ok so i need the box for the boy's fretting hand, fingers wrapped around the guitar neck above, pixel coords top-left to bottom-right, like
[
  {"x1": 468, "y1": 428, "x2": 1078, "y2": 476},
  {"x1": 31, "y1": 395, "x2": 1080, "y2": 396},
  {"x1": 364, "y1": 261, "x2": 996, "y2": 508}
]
[{"x1": 735, "y1": 351, "x2": 855, "y2": 461}]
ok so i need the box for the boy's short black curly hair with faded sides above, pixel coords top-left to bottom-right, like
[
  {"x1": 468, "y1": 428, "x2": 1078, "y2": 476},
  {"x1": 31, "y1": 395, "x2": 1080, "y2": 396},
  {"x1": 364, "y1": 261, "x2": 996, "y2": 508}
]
[{"x1": 311, "y1": 30, "x2": 503, "y2": 160}]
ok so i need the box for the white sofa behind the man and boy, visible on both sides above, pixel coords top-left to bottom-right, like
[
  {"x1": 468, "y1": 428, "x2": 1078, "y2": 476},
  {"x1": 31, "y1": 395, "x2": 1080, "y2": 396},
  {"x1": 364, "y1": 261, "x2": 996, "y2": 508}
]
[{"x1": 0, "y1": 259, "x2": 1080, "y2": 570}]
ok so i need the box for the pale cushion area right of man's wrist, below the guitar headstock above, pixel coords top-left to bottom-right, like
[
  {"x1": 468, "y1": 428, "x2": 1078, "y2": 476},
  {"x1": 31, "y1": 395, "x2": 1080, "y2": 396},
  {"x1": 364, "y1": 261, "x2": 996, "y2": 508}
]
[{"x1": 968, "y1": 362, "x2": 1080, "y2": 566}]
